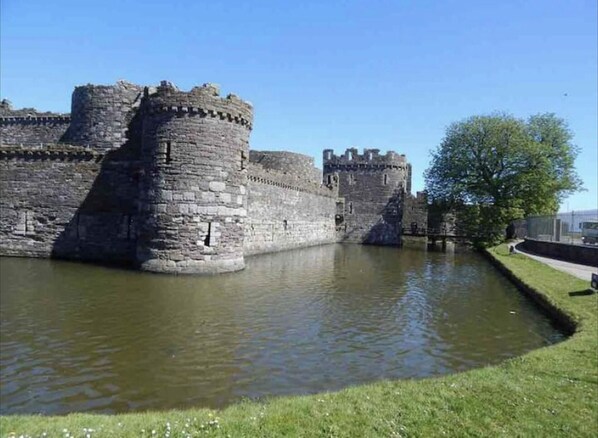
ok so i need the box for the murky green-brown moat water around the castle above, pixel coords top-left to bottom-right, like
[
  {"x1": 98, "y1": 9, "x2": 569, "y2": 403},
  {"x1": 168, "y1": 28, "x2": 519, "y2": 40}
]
[{"x1": 0, "y1": 245, "x2": 564, "y2": 414}]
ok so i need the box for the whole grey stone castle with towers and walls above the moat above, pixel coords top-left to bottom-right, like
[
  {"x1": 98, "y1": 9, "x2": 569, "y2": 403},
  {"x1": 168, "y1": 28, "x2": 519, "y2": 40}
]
[{"x1": 0, "y1": 81, "x2": 427, "y2": 274}]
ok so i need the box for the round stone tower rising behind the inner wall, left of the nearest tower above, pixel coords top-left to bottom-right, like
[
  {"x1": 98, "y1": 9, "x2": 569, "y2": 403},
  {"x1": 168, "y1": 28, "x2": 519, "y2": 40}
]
[{"x1": 62, "y1": 81, "x2": 143, "y2": 151}]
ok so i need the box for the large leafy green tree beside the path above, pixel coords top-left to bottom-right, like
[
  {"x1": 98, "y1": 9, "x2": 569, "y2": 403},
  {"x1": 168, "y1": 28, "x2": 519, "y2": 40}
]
[{"x1": 425, "y1": 114, "x2": 582, "y2": 244}]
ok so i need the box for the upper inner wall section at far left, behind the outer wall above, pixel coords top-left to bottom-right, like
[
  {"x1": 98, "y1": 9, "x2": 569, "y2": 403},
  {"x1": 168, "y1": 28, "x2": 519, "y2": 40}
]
[{"x1": 0, "y1": 115, "x2": 70, "y2": 147}]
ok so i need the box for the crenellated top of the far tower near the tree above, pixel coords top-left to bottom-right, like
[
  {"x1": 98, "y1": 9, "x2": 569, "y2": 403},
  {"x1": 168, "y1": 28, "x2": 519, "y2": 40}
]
[{"x1": 323, "y1": 148, "x2": 407, "y2": 170}]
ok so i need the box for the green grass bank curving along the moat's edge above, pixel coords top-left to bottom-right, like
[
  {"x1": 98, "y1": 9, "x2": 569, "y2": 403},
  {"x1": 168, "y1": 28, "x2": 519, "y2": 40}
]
[{"x1": 0, "y1": 245, "x2": 598, "y2": 437}]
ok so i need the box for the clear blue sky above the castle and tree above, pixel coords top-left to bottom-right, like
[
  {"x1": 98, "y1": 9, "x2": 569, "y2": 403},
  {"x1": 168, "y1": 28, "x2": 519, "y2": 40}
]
[{"x1": 0, "y1": 0, "x2": 598, "y2": 210}]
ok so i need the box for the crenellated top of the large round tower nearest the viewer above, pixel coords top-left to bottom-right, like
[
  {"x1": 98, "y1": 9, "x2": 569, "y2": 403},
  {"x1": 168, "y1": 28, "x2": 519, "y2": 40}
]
[{"x1": 145, "y1": 81, "x2": 253, "y2": 130}]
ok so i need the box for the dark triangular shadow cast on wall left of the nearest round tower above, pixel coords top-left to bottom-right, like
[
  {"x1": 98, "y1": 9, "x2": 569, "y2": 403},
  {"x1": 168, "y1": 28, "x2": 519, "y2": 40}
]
[{"x1": 52, "y1": 112, "x2": 141, "y2": 265}]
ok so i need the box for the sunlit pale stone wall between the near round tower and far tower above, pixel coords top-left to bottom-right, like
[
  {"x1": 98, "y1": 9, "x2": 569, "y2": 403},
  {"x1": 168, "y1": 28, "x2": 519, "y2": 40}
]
[{"x1": 244, "y1": 163, "x2": 338, "y2": 255}]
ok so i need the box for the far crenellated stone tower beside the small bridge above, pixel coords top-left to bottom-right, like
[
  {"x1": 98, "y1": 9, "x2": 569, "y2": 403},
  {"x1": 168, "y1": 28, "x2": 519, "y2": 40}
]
[{"x1": 323, "y1": 148, "x2": 411, "y2": 245}]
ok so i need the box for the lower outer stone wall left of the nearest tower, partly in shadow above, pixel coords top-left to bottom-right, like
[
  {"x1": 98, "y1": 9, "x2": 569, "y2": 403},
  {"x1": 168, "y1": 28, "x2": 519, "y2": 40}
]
[{"x1": 0, "y1": 145, "x2": 136, "y2": 263}]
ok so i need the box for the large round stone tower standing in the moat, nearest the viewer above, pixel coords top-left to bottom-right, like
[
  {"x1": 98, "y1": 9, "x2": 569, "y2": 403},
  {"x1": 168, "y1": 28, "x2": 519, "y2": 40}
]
[{"x1": 137, "y1": 82, "x2": 253, "y2": 274}]
